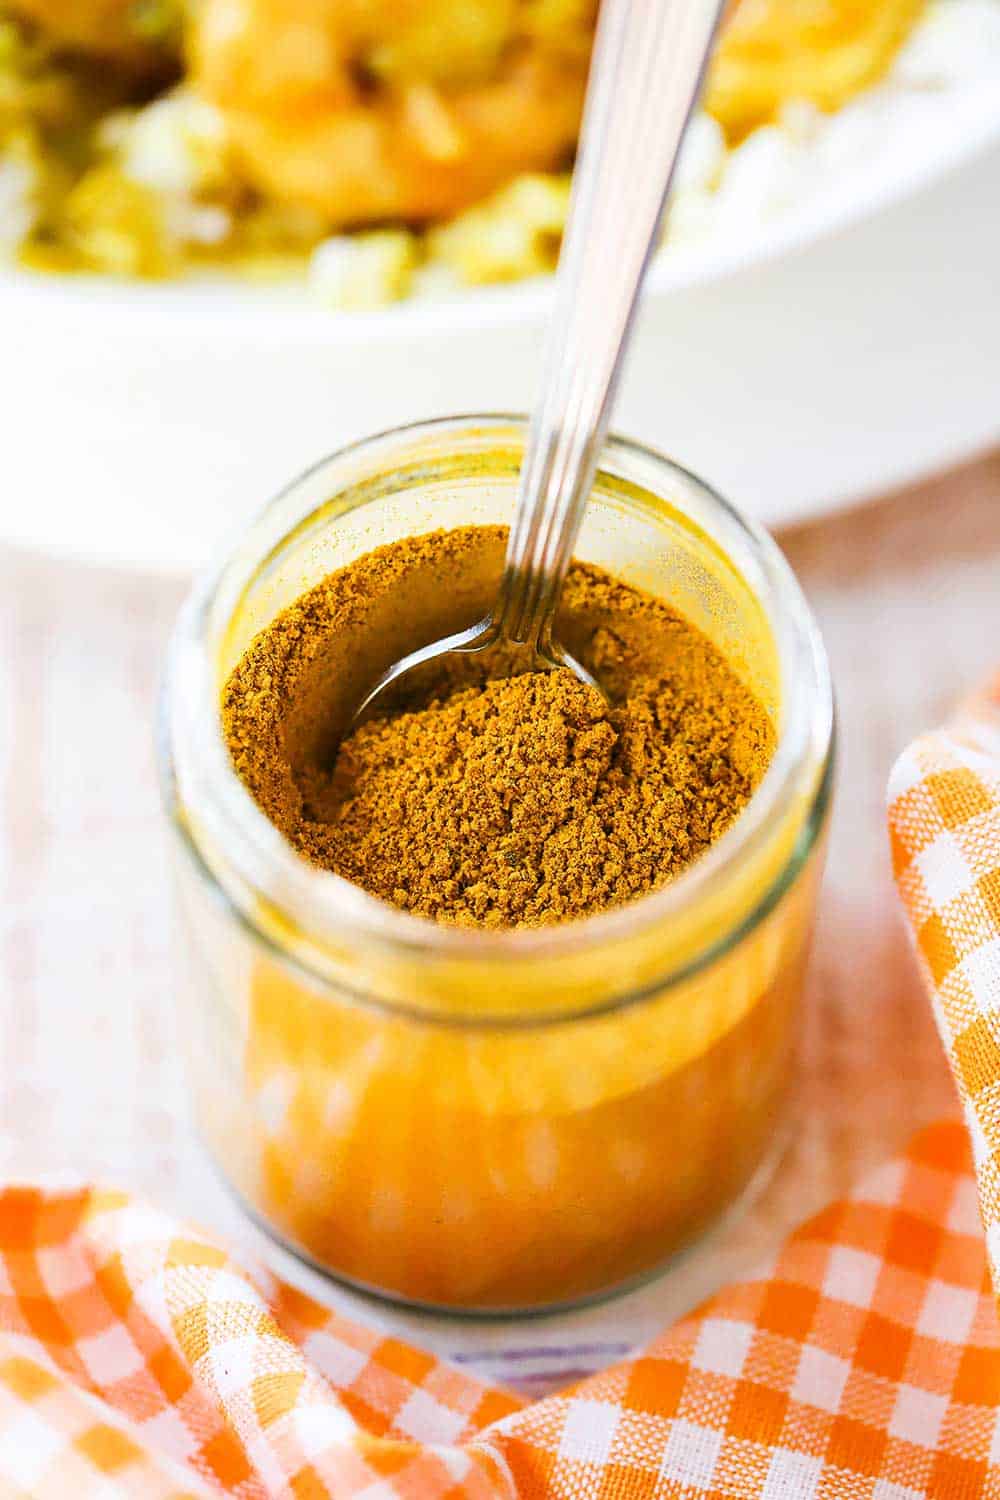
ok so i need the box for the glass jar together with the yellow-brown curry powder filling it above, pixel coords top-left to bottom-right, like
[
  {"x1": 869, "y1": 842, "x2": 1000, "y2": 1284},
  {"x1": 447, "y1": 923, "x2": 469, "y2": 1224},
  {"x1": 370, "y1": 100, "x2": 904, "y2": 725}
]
[{"x1": 163, "y1": 419, "x2": 832, "y2": 1311}]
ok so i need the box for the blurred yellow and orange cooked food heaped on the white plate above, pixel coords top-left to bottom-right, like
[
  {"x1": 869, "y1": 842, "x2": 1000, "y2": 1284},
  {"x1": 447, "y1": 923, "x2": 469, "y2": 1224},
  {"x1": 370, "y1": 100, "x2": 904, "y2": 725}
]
[{"x1": 0, "y1": 0, "x2": 1000, "y2": 306}]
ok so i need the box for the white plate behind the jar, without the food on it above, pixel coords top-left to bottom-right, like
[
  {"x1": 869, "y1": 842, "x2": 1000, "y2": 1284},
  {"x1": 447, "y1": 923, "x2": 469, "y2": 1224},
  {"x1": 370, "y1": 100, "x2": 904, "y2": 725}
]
[{"x1": 0, "y1": 80, "x2": 1000, "y2": 572}]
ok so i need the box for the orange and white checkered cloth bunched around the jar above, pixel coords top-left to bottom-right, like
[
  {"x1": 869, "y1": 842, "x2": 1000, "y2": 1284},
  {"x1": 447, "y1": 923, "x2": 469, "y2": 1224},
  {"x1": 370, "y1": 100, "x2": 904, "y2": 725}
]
[{"x1": 0, "y1": 683, "x2": 1000, "y2": 1500}]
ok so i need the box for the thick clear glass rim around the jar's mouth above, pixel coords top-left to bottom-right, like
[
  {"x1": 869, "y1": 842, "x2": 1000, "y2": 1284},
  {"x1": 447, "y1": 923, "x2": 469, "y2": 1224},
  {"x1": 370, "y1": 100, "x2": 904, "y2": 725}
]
[{"x1": 159, "y1": 413, "x2": 834, "y2": 1028}]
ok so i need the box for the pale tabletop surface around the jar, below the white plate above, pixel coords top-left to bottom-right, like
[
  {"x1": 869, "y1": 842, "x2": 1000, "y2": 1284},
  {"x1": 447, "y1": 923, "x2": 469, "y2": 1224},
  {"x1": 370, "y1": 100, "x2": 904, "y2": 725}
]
[{"x1": 0, "y1": 452, "x2": 1000, "y2": 1389}]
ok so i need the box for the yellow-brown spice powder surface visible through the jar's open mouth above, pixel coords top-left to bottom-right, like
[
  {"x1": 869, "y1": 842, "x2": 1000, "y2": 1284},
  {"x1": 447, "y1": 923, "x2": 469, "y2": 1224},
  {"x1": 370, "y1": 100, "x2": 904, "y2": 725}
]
[{"x1": 222, "y1": 527, "x2": 775, "y2": 929}]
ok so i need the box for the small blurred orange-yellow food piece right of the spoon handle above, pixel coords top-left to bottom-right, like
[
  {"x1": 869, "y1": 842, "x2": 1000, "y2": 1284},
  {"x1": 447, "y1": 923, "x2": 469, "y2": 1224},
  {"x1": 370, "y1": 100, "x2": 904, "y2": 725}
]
[{"x1": 705, "y1": 0, "x2": 924, "y2": 140}]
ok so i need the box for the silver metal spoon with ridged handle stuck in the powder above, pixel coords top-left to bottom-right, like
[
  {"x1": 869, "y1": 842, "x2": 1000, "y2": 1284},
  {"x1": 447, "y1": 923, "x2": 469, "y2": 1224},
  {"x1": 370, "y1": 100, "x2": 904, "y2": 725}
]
[{"x1": 352, "y1": 0, "x2": 721, "y2": 728}]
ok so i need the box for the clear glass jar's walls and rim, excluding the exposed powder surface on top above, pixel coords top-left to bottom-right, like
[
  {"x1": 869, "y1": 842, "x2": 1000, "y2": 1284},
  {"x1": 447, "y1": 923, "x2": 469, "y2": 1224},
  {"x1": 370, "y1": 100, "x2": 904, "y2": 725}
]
[{"x1": 162, "y1": 417, "x2": 832, "y2": 1311}]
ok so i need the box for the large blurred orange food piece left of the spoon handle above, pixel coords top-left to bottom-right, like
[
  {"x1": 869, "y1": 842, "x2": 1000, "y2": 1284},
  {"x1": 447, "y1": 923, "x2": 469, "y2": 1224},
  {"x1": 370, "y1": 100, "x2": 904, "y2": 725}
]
[{"x1": 190, "y1": 0, "x2": 597, "y2": 225}]
